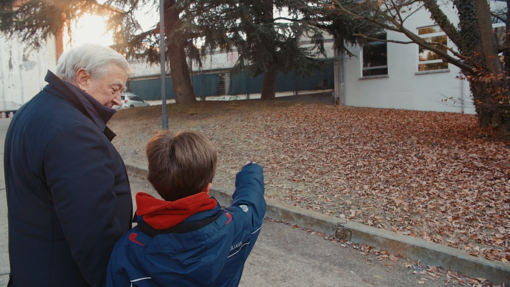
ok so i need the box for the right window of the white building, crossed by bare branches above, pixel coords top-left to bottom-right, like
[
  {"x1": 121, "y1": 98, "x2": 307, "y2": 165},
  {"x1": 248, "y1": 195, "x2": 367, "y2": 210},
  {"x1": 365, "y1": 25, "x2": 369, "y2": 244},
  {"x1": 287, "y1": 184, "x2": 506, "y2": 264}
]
[{"x1": 418, "y1": 26, "x2": 448, "y2": 71}]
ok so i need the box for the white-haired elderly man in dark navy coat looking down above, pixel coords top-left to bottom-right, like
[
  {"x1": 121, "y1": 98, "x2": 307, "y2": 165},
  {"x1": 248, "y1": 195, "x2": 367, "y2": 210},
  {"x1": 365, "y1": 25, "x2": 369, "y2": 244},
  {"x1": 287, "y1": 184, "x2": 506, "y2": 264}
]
[{"x1": 4, "y1": 44, "x2": 132, "y2": 287}]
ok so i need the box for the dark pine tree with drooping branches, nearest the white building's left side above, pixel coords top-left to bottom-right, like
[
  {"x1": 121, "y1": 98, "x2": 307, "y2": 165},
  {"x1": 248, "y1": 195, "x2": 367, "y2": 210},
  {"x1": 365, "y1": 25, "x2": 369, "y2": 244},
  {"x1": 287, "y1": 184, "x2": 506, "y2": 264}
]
[{"x1": 183, "y1": 0, "x2": 377, "y2": 100}]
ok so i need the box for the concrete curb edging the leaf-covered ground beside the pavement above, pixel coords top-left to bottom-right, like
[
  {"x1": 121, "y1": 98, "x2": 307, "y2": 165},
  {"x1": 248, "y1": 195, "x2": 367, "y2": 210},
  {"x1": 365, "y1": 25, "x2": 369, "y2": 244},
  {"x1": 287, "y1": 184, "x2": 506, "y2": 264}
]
[{"x1": 126, "y1": 164, "x2": 510, "y2": 285}]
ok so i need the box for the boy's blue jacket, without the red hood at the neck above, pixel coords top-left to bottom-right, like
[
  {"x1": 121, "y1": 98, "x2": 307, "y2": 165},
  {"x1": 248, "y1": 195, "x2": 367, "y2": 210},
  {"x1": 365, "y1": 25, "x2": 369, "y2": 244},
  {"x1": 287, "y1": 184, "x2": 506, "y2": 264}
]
[{"x1": 107, "y1": 164, "x2": 266, "y2": 287}]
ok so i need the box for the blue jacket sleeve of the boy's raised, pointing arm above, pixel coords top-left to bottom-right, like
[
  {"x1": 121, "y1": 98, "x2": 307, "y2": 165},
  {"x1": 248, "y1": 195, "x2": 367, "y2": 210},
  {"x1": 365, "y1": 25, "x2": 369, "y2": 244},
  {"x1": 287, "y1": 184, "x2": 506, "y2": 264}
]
[{"x1": 230, "y1": 163, "x2": 266, "y2": 232}]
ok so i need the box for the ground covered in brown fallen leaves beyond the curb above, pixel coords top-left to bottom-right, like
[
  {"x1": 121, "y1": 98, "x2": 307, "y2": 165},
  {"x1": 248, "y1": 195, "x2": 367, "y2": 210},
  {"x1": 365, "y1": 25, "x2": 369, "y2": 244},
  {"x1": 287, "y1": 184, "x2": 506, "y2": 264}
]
[{"x1": 109, "y1": 101, "x2": 510, "y2": 262}]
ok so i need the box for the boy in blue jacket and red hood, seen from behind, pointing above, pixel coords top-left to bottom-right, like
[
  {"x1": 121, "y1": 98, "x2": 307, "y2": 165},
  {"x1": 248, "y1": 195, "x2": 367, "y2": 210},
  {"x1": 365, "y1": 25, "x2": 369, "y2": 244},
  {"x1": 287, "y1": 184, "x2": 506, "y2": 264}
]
[{"x1": 107, "y1": 131, "x2": 266, "y2": 287}]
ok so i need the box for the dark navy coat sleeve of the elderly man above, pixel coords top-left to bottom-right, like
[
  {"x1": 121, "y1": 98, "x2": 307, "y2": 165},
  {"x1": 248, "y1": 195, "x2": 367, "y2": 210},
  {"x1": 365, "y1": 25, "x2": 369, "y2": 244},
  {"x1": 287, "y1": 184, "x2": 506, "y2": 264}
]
[{"x1": 44, "y1": 124, "x2": 127, "y2": 286}]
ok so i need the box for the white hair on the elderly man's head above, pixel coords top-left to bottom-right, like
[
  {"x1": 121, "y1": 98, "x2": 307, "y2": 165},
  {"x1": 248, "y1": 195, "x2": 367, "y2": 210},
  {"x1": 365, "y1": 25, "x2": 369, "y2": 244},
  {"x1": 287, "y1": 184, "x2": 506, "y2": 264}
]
[{"x1": 57, "y1": 43, "x2": 131, "y2": 82}]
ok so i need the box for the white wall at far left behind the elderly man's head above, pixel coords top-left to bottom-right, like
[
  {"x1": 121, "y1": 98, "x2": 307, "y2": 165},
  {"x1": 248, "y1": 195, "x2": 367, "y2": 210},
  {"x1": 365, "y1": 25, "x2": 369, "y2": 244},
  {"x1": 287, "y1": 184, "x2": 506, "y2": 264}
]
[{"x1": 0, "y1": 35, "x2": 57, "y2": 111}]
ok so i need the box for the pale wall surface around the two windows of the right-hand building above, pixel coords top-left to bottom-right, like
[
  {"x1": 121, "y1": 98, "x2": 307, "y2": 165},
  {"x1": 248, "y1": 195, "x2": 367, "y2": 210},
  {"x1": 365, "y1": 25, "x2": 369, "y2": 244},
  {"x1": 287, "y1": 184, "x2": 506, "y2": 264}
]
[{"x1": 338, "y1": 5, "x2": 475, "y2": 113}]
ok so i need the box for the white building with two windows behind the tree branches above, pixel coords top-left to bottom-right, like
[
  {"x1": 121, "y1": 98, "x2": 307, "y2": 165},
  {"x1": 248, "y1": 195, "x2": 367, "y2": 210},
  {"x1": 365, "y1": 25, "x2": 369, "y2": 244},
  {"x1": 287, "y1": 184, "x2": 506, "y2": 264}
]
[{"x1": 336, "y1": 4, "x2": 475, "y2": 114}]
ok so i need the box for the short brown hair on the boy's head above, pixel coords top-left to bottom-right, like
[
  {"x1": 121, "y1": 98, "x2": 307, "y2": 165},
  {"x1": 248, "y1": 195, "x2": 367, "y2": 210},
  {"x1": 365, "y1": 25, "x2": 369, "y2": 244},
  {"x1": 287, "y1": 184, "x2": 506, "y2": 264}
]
[{"x1": 147, "y1": 131, "x2": 218, "y2": 201}]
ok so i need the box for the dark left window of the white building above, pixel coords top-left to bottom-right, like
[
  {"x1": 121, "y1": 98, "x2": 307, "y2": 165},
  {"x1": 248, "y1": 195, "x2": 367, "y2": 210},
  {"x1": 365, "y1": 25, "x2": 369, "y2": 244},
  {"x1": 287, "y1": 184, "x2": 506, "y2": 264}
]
[{"x1": 363, "y1": 34, "x2": 388, "y2": 77}]
